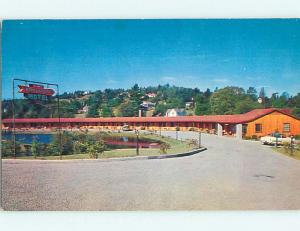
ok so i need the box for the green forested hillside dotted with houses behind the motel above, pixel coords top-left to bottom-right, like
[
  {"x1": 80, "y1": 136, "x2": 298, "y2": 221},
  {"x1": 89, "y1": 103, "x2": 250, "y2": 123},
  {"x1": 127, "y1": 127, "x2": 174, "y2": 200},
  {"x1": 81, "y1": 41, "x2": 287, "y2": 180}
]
[{"x1": 2, "y1": 84, "x2": 300, "y2": 118}]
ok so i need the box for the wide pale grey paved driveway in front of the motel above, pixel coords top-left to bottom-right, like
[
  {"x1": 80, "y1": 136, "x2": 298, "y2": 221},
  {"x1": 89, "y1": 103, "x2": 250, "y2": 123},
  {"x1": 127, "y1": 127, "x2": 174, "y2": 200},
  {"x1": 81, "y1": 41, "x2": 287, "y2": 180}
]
[{"x1": 3, "y1": 132, "x2": 300, "y2": 210}]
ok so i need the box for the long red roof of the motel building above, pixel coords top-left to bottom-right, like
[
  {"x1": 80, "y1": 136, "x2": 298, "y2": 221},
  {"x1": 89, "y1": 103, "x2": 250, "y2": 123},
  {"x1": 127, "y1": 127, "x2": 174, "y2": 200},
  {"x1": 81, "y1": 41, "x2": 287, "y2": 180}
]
[{"x1": 3, "y1": 108, "x2": 298, "y2": 124}]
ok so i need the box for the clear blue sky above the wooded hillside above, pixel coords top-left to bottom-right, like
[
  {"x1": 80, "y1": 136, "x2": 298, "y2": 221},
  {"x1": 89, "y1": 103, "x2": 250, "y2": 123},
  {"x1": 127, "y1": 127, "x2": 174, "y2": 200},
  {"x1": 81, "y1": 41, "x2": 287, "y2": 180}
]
[{"x1": 2, "y1": 19, "x2": 300, "y2": 98}]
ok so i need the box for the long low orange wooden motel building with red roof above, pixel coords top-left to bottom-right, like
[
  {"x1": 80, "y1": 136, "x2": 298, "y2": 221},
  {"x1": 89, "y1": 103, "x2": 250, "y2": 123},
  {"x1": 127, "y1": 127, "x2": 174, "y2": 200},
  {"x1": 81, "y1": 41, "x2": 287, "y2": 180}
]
[{"x1": 2, "y1": 108, "x2": 300, "y2": 139}]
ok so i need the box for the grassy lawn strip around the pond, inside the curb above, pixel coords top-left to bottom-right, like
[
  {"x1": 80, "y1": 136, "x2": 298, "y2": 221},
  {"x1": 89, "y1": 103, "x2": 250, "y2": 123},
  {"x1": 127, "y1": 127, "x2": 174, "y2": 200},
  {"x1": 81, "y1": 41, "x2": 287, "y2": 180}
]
[{"x1": 9, "y1": 132, "x2": 197, "y2": 160}]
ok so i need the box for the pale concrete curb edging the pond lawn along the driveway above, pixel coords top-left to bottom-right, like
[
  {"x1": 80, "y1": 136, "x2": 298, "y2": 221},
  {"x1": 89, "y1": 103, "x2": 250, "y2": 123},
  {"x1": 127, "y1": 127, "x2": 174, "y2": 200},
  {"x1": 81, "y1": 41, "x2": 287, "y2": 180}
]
[{"x1": 2, "y1": 148, "x2": 207, "y2": 164}]
